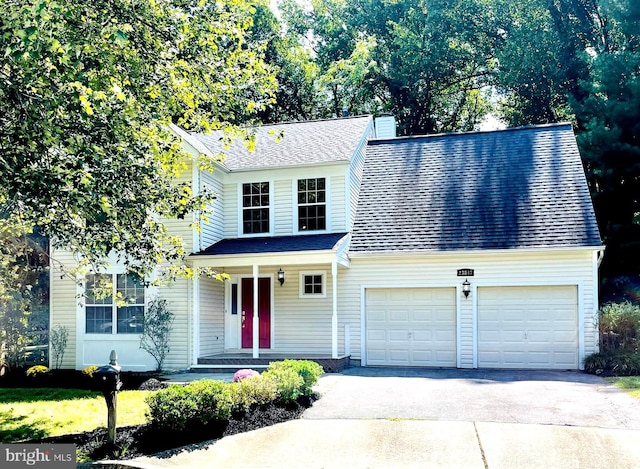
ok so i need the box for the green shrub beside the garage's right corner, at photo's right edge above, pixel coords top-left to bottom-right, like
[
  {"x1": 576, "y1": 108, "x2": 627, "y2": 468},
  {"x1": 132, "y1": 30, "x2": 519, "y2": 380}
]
[{"x1": 598, "y1": 301, "x2": 640, "y2": 352}]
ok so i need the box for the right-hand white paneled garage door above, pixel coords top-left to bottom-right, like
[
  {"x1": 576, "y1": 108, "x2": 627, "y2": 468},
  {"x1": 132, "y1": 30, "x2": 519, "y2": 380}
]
[{"x1": 478, "y1": 286, "x2": 578, "y2": 369}]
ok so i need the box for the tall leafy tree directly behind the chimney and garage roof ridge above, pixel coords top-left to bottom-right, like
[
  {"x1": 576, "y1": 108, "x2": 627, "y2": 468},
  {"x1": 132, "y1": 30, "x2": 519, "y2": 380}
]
[{"x1": 285, "y1": 0, "x2": 496, "y2": 135}]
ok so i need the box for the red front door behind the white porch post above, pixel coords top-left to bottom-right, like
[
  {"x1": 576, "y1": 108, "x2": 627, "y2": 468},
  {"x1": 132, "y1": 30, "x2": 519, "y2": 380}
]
[{"x1": 242, "y1": 278, "x2": 271, "y2": 348}]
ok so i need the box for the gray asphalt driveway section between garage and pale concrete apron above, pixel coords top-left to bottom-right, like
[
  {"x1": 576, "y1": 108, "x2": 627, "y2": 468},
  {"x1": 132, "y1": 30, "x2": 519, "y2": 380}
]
[{"x1": 303, "y1": 368, "x2": 640, "y2": 430}]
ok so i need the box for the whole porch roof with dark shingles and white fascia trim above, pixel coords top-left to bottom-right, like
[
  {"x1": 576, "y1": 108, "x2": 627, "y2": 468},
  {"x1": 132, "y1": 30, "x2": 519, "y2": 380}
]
[{"x1": 189, "y1": 232, "x2": 348, "y2": 266}]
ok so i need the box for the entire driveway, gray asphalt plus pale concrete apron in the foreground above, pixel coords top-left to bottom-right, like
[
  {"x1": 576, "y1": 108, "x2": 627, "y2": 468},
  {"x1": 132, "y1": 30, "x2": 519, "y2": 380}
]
[{"x1": 130, "y1": 368, "x2": 640, "y2": 469}]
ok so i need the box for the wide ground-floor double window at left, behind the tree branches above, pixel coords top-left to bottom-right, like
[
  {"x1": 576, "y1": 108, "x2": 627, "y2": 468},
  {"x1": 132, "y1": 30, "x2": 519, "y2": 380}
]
[{"x1": 85, "y1": 274, "x2": 145, "y2": 334}]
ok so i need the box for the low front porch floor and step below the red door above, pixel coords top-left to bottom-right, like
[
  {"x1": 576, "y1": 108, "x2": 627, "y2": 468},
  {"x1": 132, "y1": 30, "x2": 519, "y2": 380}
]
[{"x1": 191, "y1": 352, "x2": 350, "y2": 373}]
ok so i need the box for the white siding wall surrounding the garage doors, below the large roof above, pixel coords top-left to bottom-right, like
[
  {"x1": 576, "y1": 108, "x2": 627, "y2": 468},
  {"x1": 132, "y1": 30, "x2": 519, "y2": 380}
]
[{"x1": 338, "y1": 250, "x2": 597, "y2": 368}]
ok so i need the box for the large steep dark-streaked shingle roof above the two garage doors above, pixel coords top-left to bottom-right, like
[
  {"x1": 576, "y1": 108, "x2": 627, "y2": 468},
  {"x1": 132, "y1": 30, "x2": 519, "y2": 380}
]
[{"x1": 350, "y1": 124, "x2": 602, "y2": 252}]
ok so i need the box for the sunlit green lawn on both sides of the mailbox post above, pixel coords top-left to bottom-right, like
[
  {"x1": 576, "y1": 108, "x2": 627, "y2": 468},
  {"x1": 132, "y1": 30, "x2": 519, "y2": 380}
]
[{"x1": 0, "y1": 388, "x2": 153, "y2": 443}]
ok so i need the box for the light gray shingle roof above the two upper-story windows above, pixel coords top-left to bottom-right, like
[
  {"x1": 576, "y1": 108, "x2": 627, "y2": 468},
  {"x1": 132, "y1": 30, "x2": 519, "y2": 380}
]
[{"x1": 191, "y1": 116, "x2": 372, "y2": 171}]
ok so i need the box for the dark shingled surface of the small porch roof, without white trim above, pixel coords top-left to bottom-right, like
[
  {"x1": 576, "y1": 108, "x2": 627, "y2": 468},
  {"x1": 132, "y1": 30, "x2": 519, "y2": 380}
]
[{"x1": 194, "y1": 233, "x2": 347, "y2": 256}]
